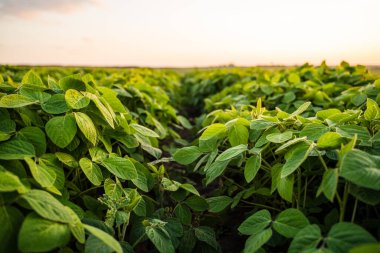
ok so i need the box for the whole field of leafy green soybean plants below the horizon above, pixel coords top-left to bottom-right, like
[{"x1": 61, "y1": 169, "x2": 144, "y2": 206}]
[{"x1": 0, "y1": 62, "x2": 380, "y2": 253}]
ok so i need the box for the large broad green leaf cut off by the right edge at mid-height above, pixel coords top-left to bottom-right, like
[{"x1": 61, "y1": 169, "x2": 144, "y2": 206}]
[{"x1": 340, "y1": 150, "x2": 380, "y2": 190}]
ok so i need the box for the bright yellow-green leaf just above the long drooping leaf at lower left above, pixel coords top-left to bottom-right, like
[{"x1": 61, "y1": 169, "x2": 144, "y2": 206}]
[{"x1": 25, "y1": 157, "x2": 57, "y2": 187}]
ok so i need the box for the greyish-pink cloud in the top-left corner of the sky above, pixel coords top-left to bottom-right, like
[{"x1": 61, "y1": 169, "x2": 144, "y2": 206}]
[{"x1": 0, "y1": 0, "x2": 98, "y2": 18}]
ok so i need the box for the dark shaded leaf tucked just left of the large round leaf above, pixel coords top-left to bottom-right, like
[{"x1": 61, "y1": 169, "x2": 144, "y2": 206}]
[{"x1": 18, "y1": 127, "x2": 46, "y2": 156}]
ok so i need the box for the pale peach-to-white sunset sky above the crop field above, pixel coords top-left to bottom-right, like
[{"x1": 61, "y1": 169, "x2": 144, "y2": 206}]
[{"x1": 0, "y1": 0, "x2": 380, "y2": 67}]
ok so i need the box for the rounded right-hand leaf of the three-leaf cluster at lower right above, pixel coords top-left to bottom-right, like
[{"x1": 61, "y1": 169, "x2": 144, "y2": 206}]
[{"x1": 273, "y1": 208, "x2": 309, "y2": 238}]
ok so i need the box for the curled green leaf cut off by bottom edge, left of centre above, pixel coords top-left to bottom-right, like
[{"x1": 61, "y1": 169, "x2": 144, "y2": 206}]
[{"x1": 145, "y1": 226, "x2": 175, "y2": 253}]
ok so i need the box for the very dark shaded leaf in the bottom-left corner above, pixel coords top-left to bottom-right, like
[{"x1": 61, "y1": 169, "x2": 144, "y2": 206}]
[{"x1": 0, "y1": 205, "x2": 24, "y2": 252}]
